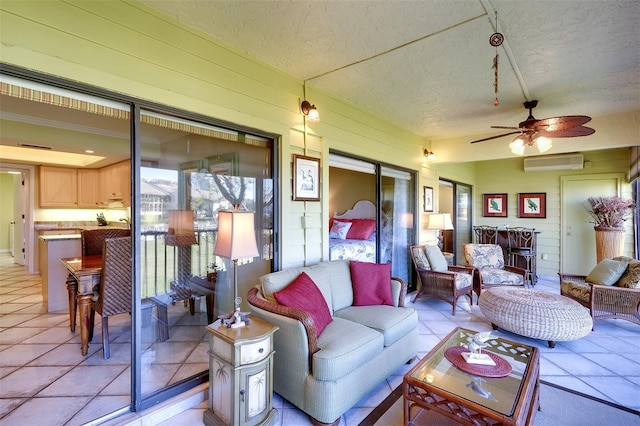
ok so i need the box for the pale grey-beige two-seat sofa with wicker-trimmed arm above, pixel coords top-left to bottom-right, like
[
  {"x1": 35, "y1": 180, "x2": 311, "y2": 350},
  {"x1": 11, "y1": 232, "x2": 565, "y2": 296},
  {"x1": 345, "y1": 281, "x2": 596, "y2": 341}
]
[{"x1": 247, "y1": 260, "x2": 418, "y2": 424}]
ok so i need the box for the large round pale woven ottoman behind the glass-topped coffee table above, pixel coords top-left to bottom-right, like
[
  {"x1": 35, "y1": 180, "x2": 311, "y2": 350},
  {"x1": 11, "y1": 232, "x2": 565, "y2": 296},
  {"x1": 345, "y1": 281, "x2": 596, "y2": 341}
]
[{"x1": 478, "y1": 287, "x2": 593, "y2": 348}]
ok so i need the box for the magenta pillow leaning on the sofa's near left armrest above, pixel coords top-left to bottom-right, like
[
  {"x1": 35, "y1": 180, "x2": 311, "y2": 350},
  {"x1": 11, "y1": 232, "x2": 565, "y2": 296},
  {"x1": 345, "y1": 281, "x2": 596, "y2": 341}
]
[{"x1": 273, "y1": 272, "x2": 333, "y2": 336}]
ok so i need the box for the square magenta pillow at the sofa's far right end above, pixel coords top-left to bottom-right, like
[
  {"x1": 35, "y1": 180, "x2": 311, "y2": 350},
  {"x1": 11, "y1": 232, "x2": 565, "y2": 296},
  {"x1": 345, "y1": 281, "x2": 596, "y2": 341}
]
[{"x1": 349, "y1": 260, "x2": 394, "y2": 306}]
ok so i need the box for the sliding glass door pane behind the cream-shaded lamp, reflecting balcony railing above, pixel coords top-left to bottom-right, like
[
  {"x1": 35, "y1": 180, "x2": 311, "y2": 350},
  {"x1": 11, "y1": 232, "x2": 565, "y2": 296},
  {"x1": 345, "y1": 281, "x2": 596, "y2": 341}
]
[{"x1": 139, "y1": 111, "x2": 274, "y2": 397}]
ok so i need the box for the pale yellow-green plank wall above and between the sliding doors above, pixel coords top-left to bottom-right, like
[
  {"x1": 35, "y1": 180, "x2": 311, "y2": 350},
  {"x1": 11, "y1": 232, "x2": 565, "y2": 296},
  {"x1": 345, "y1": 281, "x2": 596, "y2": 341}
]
[{"x1": 0, "y1": 0, "x2": 637, "y2": 273}]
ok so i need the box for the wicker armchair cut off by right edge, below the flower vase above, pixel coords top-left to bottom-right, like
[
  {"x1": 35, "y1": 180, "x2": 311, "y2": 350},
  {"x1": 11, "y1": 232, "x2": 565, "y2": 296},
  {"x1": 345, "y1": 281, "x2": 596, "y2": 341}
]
[{"x1": 559, "y1": 256, "x2": 640, "y2": 328}]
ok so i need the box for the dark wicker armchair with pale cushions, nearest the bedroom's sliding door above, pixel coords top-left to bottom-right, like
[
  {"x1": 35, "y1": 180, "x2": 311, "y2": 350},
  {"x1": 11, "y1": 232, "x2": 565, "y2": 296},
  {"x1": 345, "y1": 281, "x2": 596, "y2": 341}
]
[{"x1": 410, "y1": 245, "x2": 474, "y2": 315}]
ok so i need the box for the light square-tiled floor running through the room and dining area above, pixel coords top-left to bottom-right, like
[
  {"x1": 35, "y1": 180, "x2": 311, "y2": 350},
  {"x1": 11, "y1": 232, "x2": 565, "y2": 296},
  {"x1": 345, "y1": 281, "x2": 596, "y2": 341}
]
[{"x1": 0, "y1": 254, "x2": 640, "y2": 426}]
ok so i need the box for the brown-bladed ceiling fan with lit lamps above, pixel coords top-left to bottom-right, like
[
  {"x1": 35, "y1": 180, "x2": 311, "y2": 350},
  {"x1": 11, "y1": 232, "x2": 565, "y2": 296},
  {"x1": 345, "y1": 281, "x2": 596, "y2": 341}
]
[{"x1": 471, "y1": 100, "x2": 595, "y2": 155}]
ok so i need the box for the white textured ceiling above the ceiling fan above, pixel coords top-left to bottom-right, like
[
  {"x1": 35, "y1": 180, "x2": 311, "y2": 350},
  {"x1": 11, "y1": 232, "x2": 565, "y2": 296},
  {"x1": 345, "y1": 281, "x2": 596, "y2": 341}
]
[{"x1": 144, "y1": 0, "x2": 640, "y2": 144}]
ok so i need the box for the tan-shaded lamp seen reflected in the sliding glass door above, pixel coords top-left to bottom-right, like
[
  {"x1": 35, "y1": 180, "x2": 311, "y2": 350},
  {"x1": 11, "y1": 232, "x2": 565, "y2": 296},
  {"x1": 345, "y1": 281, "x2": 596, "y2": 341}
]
[{"x1": 166, "y1": 210, "x2": 198, "y2": 284}]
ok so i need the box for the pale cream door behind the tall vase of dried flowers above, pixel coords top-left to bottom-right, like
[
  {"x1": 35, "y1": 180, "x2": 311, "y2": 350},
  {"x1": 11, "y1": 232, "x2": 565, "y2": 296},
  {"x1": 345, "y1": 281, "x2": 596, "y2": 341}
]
[{"x1": 560, "y1": 173, "x2": 624, "y2": 275}]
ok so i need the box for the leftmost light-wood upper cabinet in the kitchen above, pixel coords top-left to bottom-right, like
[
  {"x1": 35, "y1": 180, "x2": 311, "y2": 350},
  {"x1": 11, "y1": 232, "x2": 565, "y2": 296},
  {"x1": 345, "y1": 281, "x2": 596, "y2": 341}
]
[{"x1": 39, "y1": 166, "x2": 78, "y2": 208}]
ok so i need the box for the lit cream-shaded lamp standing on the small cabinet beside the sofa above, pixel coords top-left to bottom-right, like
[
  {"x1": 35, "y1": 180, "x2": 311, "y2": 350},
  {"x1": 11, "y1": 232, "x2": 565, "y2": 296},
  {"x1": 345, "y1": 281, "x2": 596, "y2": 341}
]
[{"x1": 213, "y1": 209, "x2": 259, "y2": 328}]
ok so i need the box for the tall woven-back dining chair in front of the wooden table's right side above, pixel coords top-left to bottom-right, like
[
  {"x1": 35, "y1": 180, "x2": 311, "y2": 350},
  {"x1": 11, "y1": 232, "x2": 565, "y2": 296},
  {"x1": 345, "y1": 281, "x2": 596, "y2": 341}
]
[{"x1": 89, "y1": 237, "x2": 131, "y2": 359}]
